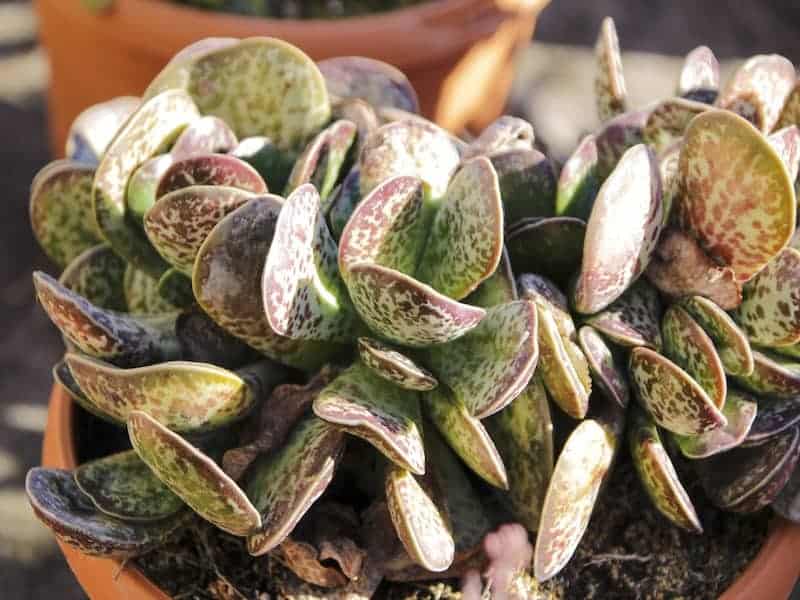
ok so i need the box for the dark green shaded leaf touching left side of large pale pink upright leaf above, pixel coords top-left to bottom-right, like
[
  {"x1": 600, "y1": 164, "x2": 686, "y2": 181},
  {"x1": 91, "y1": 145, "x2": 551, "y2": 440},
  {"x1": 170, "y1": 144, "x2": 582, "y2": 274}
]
[{"x1": 506, "y1": 217, "x2": 586, "y2": 284}]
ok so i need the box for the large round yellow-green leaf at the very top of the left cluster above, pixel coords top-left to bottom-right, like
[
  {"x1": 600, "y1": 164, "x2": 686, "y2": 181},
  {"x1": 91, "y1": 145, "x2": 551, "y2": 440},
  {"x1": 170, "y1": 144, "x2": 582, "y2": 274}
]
[{"x1": 145, "y1": 37, "x2": 331, "y2": 149}]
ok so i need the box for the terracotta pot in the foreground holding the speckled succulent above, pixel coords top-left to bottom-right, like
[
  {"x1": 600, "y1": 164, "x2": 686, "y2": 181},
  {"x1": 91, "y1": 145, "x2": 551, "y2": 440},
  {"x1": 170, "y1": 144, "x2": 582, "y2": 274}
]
[{"x1": 42, "y1": 385, "x2": 800, "y2": 600}]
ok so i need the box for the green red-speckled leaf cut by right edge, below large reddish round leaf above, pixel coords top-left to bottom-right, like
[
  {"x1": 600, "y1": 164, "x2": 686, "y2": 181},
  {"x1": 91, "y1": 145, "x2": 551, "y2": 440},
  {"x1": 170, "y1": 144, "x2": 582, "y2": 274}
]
[{"x1": 735, "y1": 248, "x2": 800, "y2": 347}]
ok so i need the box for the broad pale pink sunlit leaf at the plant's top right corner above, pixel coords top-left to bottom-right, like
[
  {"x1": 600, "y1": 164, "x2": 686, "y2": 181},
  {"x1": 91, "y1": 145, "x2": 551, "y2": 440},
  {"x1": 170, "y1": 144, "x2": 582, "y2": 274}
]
[{"x1": 717, "y1": 54, "x2": 796, "y2": 133}]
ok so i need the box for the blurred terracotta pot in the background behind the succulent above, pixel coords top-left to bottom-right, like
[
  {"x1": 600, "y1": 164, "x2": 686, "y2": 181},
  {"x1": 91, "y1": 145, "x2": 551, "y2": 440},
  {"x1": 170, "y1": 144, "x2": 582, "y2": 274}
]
[{"x1": 35, "y1": 0, "x2": 549, "y2": 155}]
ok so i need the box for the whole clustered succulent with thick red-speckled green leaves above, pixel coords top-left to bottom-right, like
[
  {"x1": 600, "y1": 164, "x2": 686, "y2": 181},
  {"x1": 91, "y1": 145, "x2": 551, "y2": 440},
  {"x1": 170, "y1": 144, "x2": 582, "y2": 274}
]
[{"x1": 21, "y1": 20, "x2": 800, "y2": 596}]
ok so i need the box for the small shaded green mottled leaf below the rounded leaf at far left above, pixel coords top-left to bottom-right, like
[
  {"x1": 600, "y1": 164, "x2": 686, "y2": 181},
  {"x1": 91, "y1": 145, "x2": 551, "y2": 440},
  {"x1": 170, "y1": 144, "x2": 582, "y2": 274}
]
[{"x1": 59, "y1": 244, "x2": 127, "y2": 312}]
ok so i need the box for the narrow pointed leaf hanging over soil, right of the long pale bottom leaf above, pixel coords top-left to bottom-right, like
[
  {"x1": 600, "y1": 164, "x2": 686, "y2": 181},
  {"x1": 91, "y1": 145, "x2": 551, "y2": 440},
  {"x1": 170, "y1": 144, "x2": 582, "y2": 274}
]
[{"x1": 628, "y1": 409, "x2": 703, "y2": 533}]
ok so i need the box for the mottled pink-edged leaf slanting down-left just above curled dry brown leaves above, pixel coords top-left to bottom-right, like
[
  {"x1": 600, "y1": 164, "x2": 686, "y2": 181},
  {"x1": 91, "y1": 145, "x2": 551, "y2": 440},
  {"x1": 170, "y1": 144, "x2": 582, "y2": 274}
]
[{"x1": 247, "y1": 415, "x2": 345, "y2": 556}]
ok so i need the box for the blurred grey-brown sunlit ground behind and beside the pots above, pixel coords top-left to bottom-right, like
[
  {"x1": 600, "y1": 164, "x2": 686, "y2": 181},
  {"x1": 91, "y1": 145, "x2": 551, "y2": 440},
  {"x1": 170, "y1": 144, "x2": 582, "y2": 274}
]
[{"x1": 0, "y1": 0, "x2": 800, "y2": 600}]
